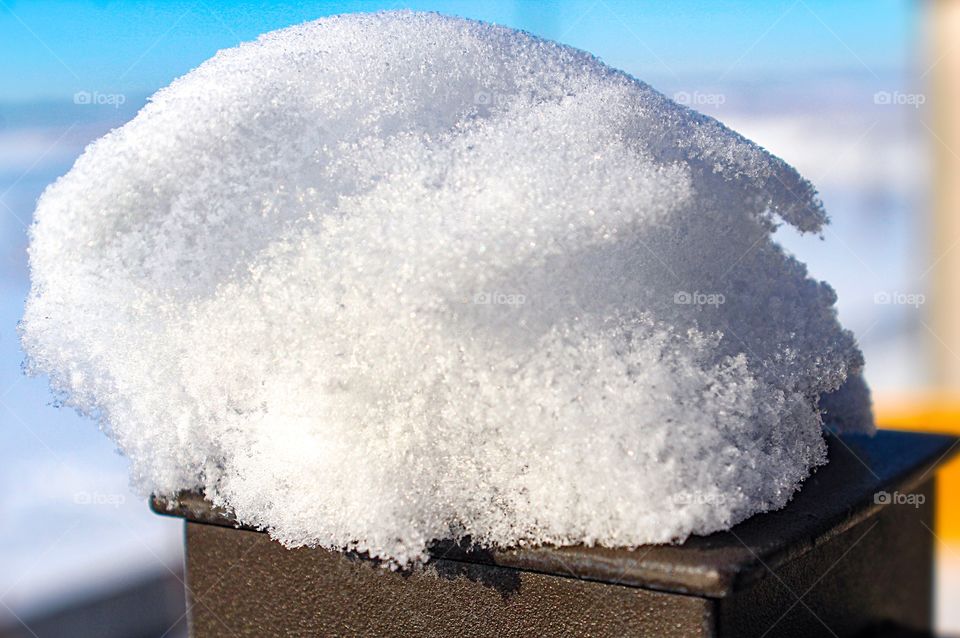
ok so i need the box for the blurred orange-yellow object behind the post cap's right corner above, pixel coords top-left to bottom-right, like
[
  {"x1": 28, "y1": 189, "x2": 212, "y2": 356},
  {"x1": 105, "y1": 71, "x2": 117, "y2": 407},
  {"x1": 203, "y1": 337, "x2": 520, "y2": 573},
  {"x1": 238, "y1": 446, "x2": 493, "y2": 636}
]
[{"x1": 874, "y1": 393, "x2": 960, "y2": 541}]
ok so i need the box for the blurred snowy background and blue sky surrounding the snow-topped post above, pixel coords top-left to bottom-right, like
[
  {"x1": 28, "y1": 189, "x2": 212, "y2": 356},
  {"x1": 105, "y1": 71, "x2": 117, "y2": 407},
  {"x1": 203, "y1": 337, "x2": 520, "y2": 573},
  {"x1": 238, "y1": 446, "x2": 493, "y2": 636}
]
[{"x1": 0, "y1": 0, "x2": 960, "y2": 636}]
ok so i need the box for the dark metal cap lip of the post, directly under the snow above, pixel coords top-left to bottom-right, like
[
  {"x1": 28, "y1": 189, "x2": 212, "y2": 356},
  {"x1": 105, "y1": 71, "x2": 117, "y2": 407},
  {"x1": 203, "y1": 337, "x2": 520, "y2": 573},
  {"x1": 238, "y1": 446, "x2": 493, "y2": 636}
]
[{"x1": 153, "y1": 431, "x2": 960, "y2": 598}]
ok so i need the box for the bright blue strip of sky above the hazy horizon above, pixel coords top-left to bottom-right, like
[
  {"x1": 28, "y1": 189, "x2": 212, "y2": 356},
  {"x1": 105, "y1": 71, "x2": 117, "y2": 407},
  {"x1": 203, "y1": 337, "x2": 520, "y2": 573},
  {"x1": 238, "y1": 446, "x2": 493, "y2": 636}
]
[{"x1": 0, "y1": 0, "x2": 917, "y2": 103}]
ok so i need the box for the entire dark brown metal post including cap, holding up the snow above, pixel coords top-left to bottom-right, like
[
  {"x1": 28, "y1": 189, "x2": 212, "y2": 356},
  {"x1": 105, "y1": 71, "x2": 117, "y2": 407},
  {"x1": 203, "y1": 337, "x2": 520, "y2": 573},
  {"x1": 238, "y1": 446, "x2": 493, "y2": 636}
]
[{"x1": 153, "y1": 432, "x2": 960, "y2": 638}]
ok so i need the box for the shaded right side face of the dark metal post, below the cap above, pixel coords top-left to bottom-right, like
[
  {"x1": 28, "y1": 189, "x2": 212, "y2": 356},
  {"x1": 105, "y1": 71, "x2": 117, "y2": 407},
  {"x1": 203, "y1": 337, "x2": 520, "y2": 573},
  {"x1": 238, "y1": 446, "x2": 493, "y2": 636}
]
[{"x1": 717, "y1": 477, "x2": 934, "y2": 638}]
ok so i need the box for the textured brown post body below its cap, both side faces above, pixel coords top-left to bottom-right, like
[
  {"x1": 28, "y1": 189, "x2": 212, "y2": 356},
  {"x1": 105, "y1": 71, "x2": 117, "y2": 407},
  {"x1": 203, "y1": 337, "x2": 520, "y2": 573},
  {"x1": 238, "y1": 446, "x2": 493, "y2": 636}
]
[{"x1": 187, "y1": 479, "x2": 933, "y2": 638}]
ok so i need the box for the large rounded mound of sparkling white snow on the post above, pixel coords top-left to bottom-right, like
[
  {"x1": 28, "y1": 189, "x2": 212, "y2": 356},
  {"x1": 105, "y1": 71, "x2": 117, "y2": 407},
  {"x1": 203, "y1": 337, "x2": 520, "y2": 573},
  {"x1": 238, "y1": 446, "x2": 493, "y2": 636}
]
[{"x1": 22, "y1": 12, "x2": 871, "y2": 563}]
